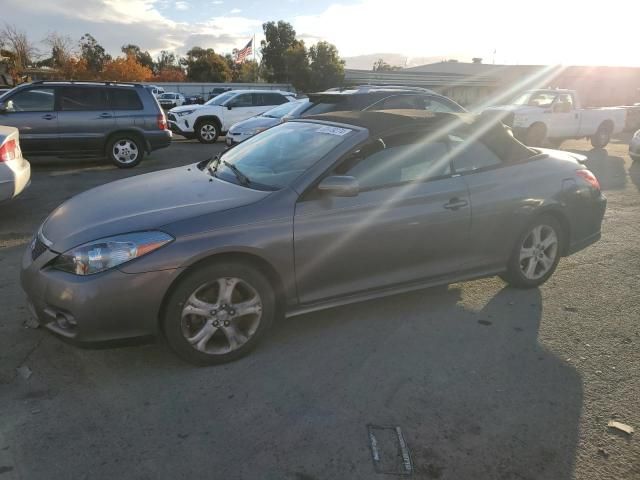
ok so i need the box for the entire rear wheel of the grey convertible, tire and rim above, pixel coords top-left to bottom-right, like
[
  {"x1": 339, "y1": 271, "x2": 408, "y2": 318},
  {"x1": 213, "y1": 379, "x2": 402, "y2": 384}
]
[{"x1": 500, "y1": 215, "x2": 564, "y2": 288}]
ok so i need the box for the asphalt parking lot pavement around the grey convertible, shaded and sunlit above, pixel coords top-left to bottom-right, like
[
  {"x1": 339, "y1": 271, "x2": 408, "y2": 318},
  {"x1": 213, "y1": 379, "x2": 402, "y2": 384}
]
[{"x1": 0, "y1": 134, "x2": 640, "y2": 480}]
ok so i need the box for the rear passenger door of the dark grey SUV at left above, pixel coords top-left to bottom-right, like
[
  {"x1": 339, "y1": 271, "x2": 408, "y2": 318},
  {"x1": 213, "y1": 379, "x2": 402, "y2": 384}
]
[{"x1": 58, "y1": 85, "x2": 115, "y2": 152}]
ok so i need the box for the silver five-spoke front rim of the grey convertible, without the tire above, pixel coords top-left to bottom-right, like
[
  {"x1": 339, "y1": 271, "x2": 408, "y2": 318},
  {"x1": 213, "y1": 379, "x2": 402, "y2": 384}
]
[{"x1": 181, "y1": 277, "x2": 262, "y2": 355}]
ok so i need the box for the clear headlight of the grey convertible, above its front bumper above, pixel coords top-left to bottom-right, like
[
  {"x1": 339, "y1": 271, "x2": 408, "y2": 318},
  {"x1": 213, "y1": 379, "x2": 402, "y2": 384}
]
[{"x1": 52, "y1": 232, "x2": 173, "y2": 275}]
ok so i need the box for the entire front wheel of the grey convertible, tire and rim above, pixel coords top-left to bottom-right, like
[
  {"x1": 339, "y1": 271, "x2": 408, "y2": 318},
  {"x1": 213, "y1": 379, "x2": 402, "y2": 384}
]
[{"x1": 162, "y1": 263, "x2": 276, "y2": 366}]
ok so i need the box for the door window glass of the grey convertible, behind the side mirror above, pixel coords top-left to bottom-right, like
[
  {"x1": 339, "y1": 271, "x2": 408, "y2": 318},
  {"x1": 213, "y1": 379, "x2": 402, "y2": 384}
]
[{"x1": 336, "y1": 134, "x2": 451, "y2": 190}]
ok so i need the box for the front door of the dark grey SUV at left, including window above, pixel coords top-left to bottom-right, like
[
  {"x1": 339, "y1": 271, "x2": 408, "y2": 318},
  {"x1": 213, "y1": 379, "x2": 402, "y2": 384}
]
[{"x1": 0, "y1": 87, "x2": 59, "y2": 153}]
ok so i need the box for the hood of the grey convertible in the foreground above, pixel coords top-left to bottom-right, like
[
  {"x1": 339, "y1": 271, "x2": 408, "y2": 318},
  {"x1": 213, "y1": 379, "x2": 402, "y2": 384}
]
[{"x1": 42, "y1": 165, "x2": 270, "y2": 253}]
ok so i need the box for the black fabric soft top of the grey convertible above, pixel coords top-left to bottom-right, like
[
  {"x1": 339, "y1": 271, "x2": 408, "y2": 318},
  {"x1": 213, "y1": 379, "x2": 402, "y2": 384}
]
[{"x1": 301, "y1": 110, "x2": 537, "y2": 161}]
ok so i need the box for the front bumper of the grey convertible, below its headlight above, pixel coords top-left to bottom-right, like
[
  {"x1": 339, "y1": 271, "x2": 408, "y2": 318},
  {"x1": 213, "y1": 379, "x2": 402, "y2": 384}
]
[{"x1": 20, "y1": 247, "x2": 177, "y2": 342}]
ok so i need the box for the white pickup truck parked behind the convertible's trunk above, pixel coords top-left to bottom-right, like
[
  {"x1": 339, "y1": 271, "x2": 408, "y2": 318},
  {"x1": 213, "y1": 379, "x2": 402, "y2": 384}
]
[{"x1": 482, "y1": 89, "x2": 627, "y2": 148}]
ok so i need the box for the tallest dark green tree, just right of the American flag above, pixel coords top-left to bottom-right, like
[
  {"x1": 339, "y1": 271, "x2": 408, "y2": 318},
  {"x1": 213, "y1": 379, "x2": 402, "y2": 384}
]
[{"x1": 260, "y1": 20, "x2": 300, "y2": 82}]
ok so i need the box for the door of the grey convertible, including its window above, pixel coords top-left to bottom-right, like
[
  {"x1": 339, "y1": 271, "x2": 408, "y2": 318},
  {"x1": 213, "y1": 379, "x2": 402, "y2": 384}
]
[{"x1": 294, "y1": 132, "x2": 471, "y2": 303}]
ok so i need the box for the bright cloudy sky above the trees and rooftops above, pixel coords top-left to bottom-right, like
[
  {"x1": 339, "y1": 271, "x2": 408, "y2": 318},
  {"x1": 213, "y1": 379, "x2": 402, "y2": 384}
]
[{"x1": 0, "y1": 0, "x2": 640, "y2": 66}]
